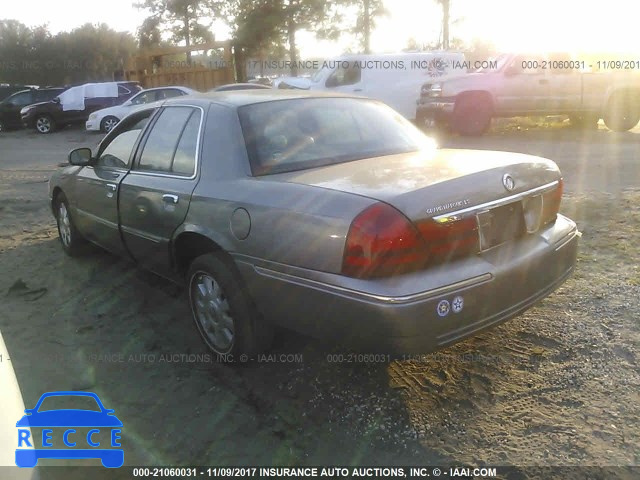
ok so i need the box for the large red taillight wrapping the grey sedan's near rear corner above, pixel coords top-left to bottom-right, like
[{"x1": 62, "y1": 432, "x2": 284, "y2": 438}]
[{"x1": 342, "y1": 203, "x2": 427, "y2": 278}]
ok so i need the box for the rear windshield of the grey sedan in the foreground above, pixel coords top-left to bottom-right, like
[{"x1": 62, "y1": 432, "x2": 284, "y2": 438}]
[{"x1": 238, "y1": 98, "x2": 431, "y2": 175}]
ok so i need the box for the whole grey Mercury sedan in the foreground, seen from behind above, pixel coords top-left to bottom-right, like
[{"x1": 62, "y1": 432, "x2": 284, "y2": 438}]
[{"x1": 49, "y1": 90, "x2": 579, "y2": 360}]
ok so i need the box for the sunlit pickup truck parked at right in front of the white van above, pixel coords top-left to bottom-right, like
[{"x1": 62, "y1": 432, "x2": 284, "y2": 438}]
[{"x1": 416, "y1": 54, "x2": 640, "y2": 135}]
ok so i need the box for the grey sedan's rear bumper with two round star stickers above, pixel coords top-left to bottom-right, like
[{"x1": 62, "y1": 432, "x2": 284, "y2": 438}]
[{"x1": 236, "y1": 215, "x2": 580, "y2": 354}]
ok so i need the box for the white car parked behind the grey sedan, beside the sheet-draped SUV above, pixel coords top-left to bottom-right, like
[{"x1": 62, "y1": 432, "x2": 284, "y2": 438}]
[{"x1": 86, "y1": 87, "x2": 198, "y2": 133}]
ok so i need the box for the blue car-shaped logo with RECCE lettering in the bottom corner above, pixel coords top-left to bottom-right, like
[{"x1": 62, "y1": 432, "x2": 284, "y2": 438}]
[{"x1": 16, "y1": 391, "x2": 124, "y2": 468}]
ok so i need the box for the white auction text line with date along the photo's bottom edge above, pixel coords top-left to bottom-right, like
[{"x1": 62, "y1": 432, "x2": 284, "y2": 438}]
[{"x1": 132, "y1": 467, "x2": 497, "y2": 478}]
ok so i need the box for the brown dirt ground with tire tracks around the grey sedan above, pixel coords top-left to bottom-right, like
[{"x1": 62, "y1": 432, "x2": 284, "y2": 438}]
[{"x1": 0, "y1": 120, "x2": 640, "y2": 476}]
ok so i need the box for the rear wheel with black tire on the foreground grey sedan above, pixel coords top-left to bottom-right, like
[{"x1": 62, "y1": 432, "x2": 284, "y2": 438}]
[{"x1": 187, "y1": 253, "x2": 273, "y2": 362}]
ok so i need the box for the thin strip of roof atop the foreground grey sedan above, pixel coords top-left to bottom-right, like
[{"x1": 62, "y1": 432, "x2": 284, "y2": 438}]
[{"x1": 164, "y1": 88, "x2": 361, "y2": 107}]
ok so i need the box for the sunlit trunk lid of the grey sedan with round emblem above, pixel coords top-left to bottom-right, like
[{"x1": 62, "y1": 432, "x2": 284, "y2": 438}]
[{"x1": 270, "y1": 149, "x2": 560, "y2": 222}]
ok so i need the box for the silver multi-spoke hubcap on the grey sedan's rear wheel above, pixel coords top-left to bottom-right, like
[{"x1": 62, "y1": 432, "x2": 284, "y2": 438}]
[{"x1": 191, "y1": 272, "x2": 235, "y2": 353}]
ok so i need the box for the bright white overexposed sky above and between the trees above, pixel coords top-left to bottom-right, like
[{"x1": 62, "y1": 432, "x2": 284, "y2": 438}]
[{"x1": 0, "y1": 0, "x2": 640, "y2": 58}]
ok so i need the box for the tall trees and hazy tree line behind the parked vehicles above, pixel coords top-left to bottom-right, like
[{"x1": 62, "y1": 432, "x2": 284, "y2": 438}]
[{"x1": 0, "y1": 0, "x2": 480, "y2": 85}]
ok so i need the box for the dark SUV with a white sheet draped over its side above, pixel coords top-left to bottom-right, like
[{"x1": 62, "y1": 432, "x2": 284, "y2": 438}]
[{"x1": 20, "y1": 82, "x2": 142, "y2": 134}]
